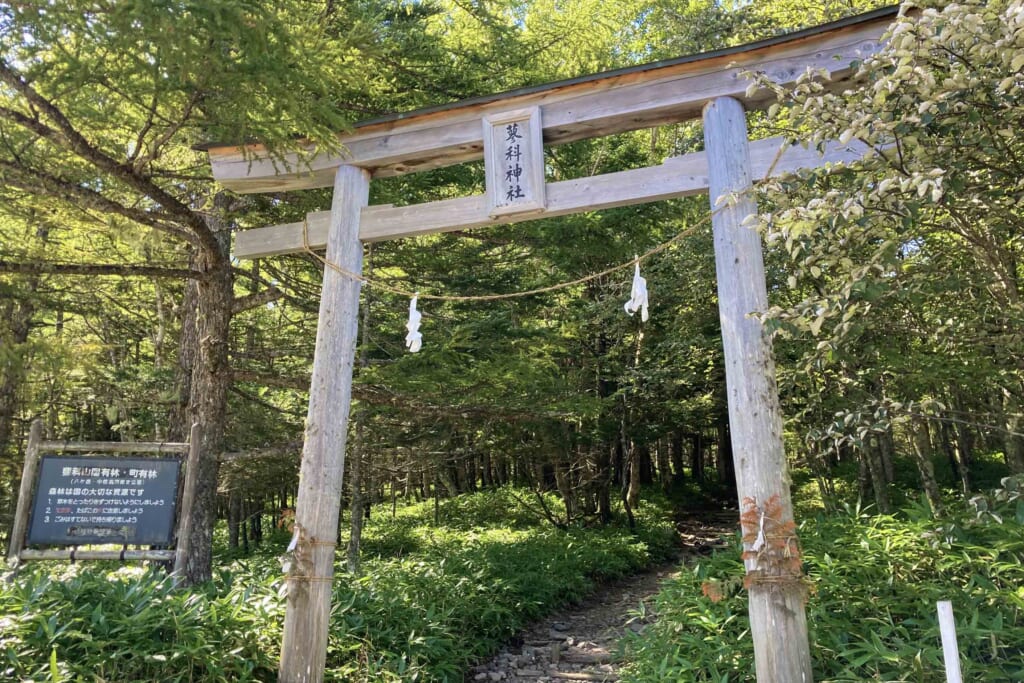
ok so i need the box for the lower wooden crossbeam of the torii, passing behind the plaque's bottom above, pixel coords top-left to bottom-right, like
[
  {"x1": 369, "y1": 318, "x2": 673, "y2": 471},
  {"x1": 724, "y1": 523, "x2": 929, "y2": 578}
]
[{"x1": 233, "y1": 137, "x2": 868, "y2": 259}]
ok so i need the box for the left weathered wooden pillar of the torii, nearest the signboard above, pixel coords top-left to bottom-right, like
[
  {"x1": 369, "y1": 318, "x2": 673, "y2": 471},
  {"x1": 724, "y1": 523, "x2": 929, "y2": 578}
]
[{"x1": 278, "y1": 166, "x2": 370, "y2": 683}]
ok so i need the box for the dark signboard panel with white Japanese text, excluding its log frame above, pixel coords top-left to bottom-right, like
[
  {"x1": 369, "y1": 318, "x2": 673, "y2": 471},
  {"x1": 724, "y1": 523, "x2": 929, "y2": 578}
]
[{"x1": 29, "y1": 456, "x2": 181, "y2": 546}]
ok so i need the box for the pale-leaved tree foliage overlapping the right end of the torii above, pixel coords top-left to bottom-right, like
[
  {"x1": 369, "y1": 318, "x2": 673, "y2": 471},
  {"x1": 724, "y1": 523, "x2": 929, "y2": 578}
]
[{"x1": 761, "y1": 0, "x2": 1024, "y2": 470}]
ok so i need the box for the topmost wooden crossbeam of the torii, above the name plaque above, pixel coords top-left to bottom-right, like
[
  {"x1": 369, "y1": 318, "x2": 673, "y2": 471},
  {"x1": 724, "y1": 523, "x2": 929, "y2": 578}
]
[{"x1": 209, "y1": 16, "x2": 891, "y2": 193}]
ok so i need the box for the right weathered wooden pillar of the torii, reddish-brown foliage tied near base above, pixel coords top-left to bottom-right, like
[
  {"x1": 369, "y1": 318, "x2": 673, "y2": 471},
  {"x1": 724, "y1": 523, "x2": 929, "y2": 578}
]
[{"x1": 703, "y1": 97, "x2": 813, "y2": 683}]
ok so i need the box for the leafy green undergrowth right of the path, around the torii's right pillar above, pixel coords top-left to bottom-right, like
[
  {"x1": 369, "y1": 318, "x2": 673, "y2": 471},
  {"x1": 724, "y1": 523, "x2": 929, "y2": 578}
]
[{"x1": 622, "y1": 497, "x2": 1024, "y2": 683}]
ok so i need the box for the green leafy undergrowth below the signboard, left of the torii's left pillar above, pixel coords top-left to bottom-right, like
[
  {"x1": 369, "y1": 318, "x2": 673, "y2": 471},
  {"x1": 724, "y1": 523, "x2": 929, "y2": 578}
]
[{"x1": 0, "y1": 566, "x2": 284, "y2": 683}]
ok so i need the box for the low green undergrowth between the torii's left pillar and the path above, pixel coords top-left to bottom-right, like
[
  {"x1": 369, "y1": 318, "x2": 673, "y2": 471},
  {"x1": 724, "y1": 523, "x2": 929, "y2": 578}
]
[{"x1": 328, "y1": 492, "x2": 673, "y2": 681}]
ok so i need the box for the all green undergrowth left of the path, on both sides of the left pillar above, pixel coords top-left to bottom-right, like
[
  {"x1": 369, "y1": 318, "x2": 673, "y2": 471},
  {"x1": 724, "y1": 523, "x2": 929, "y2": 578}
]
[{"x1": 0, "y1": 489, "x2": 674, "y2": 682}]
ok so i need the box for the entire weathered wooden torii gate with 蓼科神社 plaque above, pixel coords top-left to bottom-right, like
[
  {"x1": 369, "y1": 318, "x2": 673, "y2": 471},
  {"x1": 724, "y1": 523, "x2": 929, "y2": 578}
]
[{"x1": 208, "y1": 7, "x2": 897, "y2": 683}]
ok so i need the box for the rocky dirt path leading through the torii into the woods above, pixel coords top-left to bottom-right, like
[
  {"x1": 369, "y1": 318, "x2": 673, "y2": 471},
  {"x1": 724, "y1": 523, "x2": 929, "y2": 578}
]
[{"x1": 466, "y1": 512, "x2": 738, "y2": 683}]
